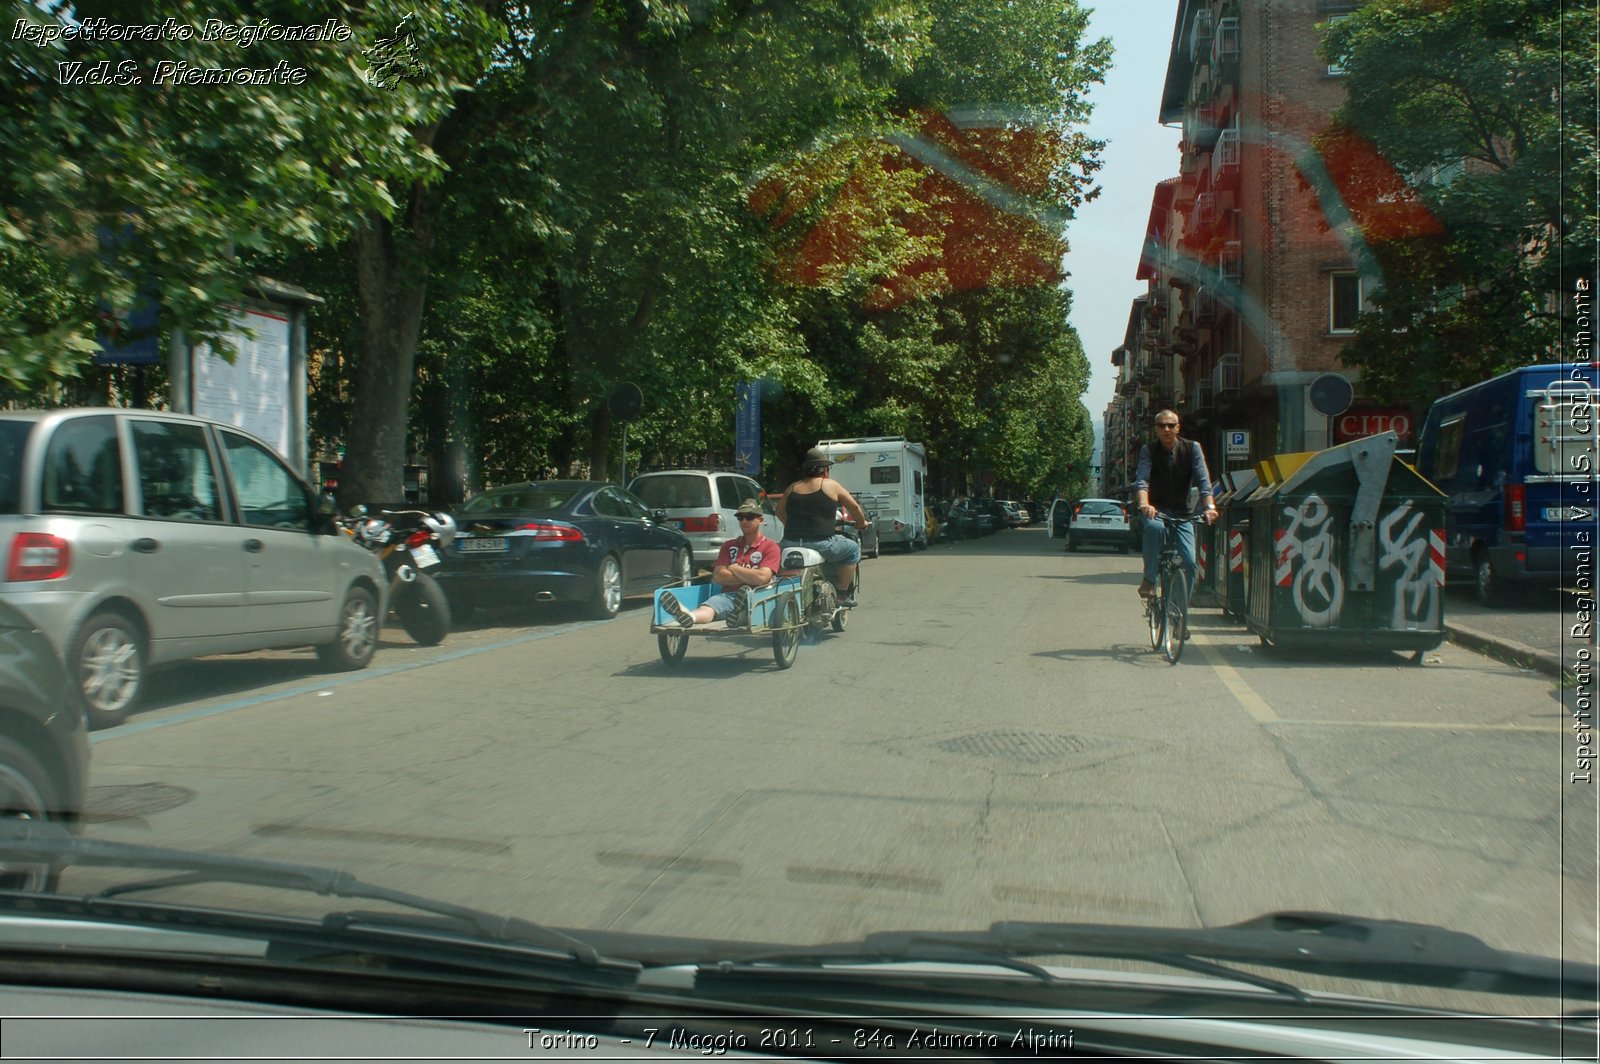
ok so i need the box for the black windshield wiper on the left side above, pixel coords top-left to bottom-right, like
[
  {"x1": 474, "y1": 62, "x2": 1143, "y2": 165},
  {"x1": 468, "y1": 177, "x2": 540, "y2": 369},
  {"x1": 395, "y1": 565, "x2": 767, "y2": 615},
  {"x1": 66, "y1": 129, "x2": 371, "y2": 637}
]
[{"x1": 0, "y1": 818, "x2": 642, "y2": 984}]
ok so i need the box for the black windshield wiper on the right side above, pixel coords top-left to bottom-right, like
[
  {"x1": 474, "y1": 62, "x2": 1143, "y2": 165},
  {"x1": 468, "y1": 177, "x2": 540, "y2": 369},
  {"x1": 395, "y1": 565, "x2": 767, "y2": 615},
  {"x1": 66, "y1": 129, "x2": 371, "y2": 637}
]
[{"x1": 701, "y1": 912, "x2": 1600, "y2": 998}]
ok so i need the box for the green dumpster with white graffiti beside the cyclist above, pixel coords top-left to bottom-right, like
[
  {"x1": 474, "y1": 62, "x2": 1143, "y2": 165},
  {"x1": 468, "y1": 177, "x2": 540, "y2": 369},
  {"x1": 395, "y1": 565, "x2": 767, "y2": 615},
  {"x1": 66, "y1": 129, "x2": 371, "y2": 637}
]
[{"x1": 1245, "y1": 432, "x2": 1445, "y2": 661}]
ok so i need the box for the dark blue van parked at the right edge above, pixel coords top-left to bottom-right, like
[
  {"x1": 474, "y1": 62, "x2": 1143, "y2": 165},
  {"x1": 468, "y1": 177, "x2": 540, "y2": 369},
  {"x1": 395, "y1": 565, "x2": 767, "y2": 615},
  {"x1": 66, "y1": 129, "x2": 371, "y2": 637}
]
[{"x1": 1416, "y1": 362, "x2": 1600, "y2": 605}]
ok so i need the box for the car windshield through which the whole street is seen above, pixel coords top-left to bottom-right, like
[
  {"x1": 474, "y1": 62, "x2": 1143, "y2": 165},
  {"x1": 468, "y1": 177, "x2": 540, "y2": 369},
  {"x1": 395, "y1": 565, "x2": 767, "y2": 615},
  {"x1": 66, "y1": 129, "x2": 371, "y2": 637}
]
[{"x1": 0, "y1": 0, "x2": 1600, "y2": 1056}]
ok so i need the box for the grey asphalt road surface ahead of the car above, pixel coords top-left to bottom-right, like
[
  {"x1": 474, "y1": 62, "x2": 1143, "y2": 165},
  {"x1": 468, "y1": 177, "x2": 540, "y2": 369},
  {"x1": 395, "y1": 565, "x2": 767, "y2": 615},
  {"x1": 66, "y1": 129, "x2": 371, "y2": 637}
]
[{"x1": 64, "y1": 528, "x2": 1597, "y2": 1011}]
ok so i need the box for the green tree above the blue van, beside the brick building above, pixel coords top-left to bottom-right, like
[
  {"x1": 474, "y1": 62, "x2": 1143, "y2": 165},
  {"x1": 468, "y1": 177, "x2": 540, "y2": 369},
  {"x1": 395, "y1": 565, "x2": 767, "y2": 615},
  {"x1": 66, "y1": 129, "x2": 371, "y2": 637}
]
[{"x1": 1323, "y1": 0, "x2": 1597, "y2": 408}]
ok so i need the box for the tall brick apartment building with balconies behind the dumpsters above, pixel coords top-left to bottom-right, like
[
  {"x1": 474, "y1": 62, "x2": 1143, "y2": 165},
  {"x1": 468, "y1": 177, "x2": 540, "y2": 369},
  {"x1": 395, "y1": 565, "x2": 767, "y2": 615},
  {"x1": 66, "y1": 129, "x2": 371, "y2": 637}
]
[{"x1": 1102, "y1": 0, "x2": 1403, "y2": 493}]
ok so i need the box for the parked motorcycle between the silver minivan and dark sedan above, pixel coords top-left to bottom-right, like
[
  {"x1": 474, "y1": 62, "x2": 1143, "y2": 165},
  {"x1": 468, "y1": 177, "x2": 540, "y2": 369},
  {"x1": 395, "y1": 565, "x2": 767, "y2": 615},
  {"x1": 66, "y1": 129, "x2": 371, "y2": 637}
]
[{"x1": 339, "y1": 506, "x2": 456, "y2": 646}]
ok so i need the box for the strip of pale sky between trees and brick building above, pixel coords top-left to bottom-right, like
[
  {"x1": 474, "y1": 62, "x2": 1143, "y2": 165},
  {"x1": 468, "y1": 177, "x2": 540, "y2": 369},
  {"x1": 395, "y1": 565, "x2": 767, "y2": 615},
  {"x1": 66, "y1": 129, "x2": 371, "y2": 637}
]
[{"x1": 1067, "y1": 0, "x2": 1181, "y2": 461}]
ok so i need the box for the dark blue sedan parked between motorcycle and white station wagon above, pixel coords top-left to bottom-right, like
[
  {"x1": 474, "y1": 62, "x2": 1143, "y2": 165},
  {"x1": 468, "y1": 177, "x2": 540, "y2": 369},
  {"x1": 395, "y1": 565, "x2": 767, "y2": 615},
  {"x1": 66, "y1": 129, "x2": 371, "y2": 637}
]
[{"x1": 434, "y1": 480, "x2": 691, "y2": 618}]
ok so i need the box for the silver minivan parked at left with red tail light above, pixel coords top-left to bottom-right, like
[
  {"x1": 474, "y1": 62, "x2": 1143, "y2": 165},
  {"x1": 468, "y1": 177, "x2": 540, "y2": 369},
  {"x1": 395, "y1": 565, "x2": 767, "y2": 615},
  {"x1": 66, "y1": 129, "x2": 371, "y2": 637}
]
[{"x1": 0, "y1": 410, "x2": 384, "y2": 728}]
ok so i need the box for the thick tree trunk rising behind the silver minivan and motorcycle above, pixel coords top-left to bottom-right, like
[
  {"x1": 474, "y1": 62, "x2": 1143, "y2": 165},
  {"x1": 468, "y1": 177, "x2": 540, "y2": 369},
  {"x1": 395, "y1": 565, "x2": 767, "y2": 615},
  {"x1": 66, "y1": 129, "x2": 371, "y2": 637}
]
[{"x1": 339, "y1": 214, "x2": 427, "y2": 507}]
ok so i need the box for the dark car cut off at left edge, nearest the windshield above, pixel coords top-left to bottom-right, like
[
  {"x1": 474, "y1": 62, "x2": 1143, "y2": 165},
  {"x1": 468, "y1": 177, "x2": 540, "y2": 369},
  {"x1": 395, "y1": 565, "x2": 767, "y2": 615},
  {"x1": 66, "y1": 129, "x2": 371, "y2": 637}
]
[{"x1": 0, "y1": 603, "x2": 90, "y2": 890}]
